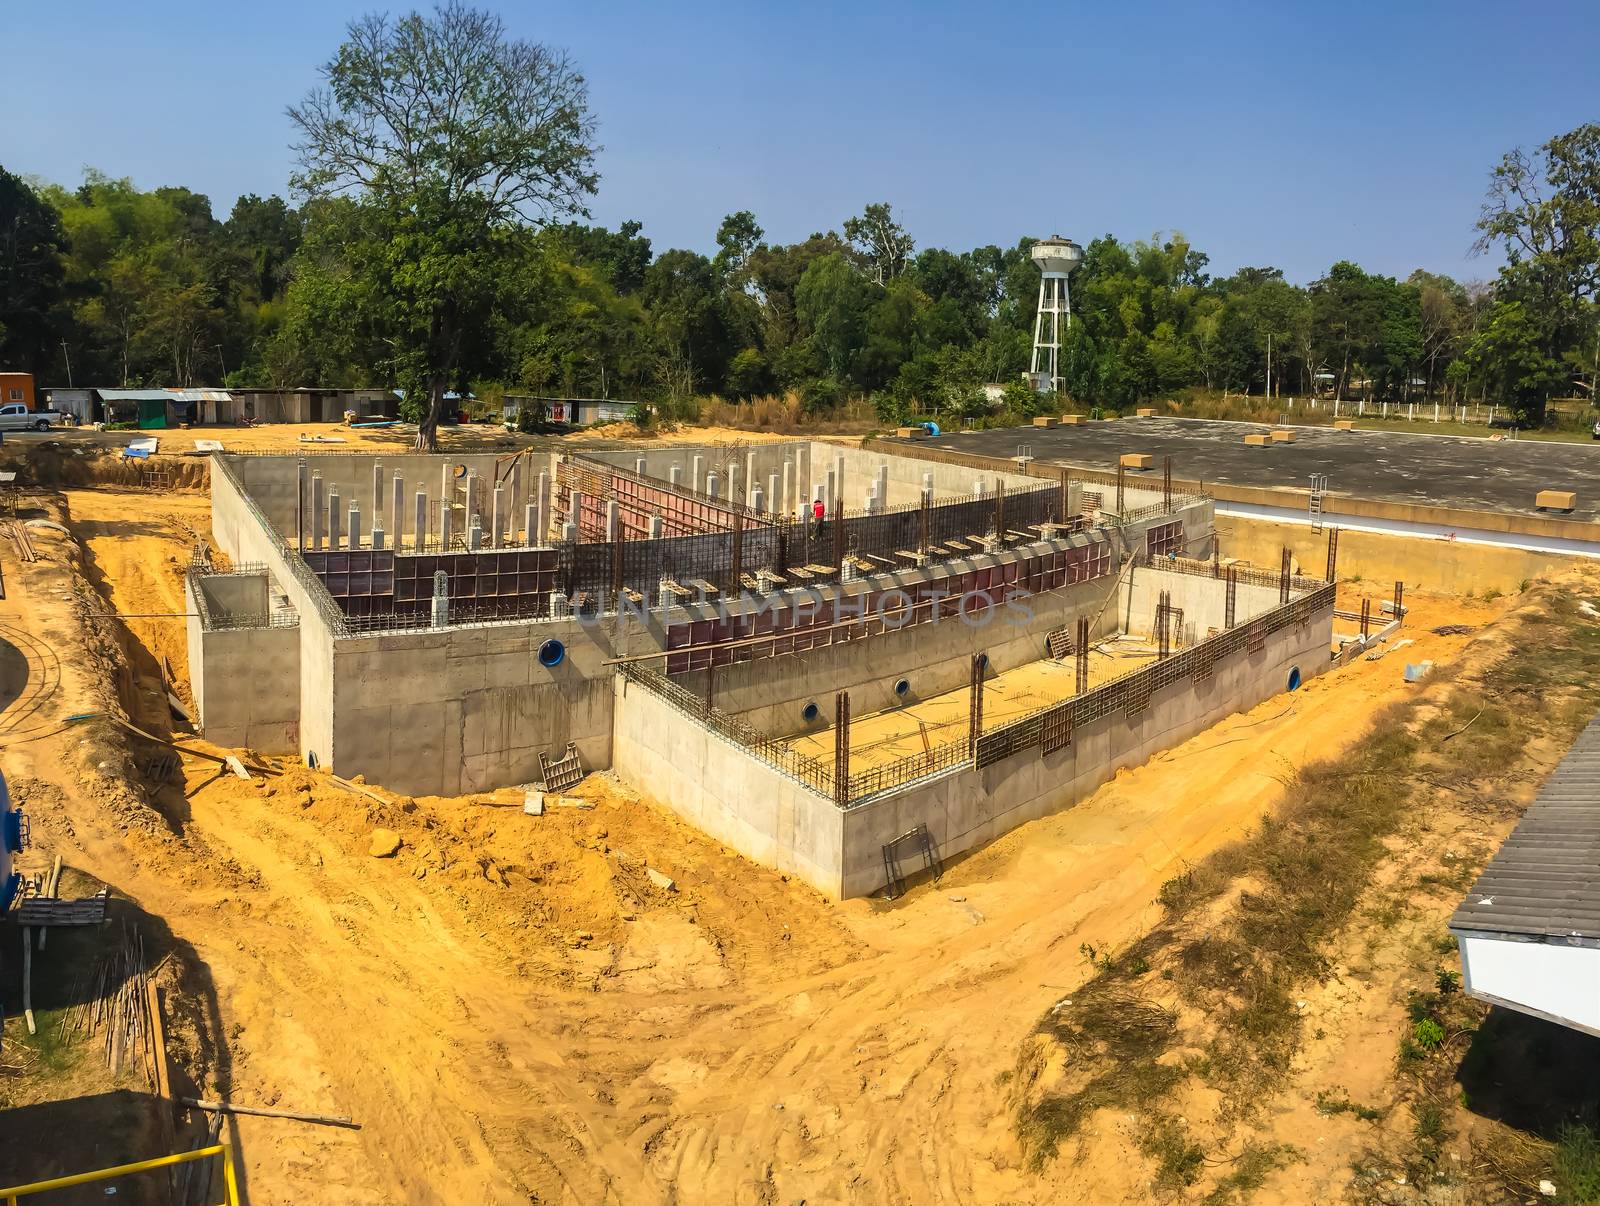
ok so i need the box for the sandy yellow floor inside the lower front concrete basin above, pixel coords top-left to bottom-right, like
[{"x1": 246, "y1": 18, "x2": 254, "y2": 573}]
[{"x1": 789, "y1": 637, "x2": 1155, "y2": 774}]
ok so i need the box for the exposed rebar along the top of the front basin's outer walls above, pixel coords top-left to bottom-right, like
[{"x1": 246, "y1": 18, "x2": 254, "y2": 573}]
[{"x1": 618, "y1": 575, "x2": 1334, "y2": 808}]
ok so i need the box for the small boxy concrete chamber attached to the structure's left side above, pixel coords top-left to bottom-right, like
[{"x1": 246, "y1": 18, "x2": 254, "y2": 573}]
[{"x1": 184, "y1": 574, "x2": 301, "y2": 753}]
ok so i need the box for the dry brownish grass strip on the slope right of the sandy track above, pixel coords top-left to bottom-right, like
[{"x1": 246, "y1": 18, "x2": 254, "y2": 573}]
[{"x1": 1013, "y1": 582, "x2": 1600, "y2": 1192}]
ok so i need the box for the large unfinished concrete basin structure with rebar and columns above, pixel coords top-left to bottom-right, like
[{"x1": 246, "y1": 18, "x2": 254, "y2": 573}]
[{"x1": 189, "y1": 441, "x2": 1333, "y2": 897}]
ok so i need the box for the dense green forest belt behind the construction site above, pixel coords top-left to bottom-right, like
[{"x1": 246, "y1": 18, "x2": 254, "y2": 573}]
[{"x1": 0, "y1": 9, "x2": 1600, "y2": 421}]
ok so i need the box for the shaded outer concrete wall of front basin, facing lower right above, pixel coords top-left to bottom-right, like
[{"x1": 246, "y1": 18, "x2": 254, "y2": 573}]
[{"x1": 818, "y1": 598, "x2": 1333, "y2": 897}]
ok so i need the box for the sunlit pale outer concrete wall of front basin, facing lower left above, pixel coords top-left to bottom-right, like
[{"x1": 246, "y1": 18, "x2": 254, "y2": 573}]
[{"x1": 614, "y1": 677, "x2": 843, "y2": 899}]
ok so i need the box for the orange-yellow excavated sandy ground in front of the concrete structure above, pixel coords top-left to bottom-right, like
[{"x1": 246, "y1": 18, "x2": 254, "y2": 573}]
[{"x1": 0, "y1": 483, "x2": 1496, "y2": 1204}]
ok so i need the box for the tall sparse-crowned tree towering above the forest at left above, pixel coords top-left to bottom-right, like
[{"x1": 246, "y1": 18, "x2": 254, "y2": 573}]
[{"x1": 288, "y1": 2, "x2": 597, "y2": 449}]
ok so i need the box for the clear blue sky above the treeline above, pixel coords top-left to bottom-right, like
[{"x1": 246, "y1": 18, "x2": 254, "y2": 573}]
[{"x1": 0, "y1": 0, "x2": 1600, "y2": 282}]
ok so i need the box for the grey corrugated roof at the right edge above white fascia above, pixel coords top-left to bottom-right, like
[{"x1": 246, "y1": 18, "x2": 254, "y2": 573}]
[{"x1": 1450, "y1": 717, "x2": 1600, "y2": 945}]
